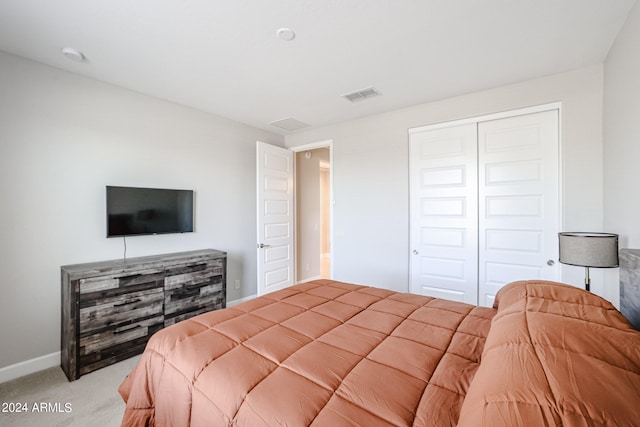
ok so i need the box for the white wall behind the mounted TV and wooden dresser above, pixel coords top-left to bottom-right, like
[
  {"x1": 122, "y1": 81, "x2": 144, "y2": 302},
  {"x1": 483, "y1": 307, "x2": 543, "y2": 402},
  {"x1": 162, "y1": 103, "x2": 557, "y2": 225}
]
[{"x1": 0, "y1": 53, "x2": 283, "y2": 368}]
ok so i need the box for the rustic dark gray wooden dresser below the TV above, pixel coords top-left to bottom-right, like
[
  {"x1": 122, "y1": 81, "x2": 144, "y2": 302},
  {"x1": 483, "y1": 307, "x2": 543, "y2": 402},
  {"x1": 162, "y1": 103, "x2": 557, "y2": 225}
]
[{"x1": 60, "y1": 249, "x2": 227, "y2": 381}]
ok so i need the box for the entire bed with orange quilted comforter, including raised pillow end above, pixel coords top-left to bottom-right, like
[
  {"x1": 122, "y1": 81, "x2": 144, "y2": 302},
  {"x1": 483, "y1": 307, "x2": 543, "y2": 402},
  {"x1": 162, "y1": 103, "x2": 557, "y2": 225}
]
[{"x1": 119, "y1": 280, "x2": 640, "y2": 427}]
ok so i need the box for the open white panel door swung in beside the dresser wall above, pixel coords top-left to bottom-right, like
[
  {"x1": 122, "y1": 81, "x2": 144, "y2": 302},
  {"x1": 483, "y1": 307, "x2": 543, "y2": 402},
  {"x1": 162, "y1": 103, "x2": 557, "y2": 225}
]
[{"x1": 256, "y1": 142, "x2": 294, "y2": 295}]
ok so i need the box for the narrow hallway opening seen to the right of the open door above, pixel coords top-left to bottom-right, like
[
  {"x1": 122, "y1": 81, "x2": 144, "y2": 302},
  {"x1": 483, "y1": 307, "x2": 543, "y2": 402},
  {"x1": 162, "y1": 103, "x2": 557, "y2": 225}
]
[{"x1": 295, "y1": 146, "x2": 331, "y2": 283}]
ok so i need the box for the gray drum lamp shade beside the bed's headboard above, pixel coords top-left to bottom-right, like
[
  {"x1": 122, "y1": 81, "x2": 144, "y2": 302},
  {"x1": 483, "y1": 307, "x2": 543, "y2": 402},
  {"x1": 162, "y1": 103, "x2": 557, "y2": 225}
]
[{"x1": 558, "y1": 233, "x2": 618, "y2": 268}]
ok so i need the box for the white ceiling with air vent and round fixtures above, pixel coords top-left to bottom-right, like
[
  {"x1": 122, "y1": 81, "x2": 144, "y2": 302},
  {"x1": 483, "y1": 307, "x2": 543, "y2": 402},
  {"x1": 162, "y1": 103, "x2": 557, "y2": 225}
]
[{"x1": 0, "y1": 0, "x2": 635, "y2": 134}]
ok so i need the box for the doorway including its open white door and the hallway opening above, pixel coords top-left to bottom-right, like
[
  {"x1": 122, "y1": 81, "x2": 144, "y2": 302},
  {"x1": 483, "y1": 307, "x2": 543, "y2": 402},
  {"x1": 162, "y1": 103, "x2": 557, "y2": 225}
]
[{"x1": 256, "y1": 140, "x2": 333, "y2": 295}]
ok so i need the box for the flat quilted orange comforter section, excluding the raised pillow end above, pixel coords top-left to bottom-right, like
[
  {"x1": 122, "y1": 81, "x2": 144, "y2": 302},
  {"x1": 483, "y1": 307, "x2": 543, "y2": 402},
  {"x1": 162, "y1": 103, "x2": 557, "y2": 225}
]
[{"x1": 120, "y1": 280, "x2": 495, "y2": 427}]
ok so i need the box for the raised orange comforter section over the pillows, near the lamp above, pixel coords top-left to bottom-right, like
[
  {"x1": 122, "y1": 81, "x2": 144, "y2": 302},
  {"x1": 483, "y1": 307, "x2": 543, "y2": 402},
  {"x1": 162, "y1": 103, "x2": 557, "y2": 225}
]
[{"x1": 459, "y1": 282, "x2": 640, "y2": 427}]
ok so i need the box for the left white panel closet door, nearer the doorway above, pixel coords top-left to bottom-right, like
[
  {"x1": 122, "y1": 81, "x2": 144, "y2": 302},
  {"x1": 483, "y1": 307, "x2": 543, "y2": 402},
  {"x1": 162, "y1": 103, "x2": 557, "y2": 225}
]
[{"x1": 409, "y1": 123, "x2": 478, "y2": 304}]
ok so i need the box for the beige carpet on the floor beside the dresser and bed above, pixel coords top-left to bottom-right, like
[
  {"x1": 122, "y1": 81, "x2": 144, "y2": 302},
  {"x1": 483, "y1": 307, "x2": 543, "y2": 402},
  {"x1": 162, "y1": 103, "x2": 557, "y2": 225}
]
[{"x1": 0, "y1": 356, "x2": 140, "y2": 427}]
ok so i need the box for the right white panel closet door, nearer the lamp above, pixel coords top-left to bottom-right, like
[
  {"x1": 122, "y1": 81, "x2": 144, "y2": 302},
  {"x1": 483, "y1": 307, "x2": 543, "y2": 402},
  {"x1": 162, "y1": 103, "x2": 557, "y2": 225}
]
[{"x1": 478, "y1": 110, "x2": 559, "y2": 306}]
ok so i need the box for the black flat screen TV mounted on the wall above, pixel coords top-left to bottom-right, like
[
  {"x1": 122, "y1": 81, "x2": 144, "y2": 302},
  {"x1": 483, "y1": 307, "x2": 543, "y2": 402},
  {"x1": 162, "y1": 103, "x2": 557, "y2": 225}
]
[{"x1": 107, "y1": 186, "x2": 193, "y2": 237}]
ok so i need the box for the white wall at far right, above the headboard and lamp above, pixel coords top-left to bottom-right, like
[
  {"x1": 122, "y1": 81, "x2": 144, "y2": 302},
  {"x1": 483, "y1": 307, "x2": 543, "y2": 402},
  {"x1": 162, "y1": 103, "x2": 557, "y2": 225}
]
[{"x1": 604, "y1": 3, "x2": 640, "y2": 254}]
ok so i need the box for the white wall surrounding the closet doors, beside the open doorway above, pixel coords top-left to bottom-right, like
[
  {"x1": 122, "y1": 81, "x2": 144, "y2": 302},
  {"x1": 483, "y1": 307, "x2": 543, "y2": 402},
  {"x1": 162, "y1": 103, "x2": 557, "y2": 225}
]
[{"x1": 285, "y1": 65, "x2": 604, "y2": 297}]
